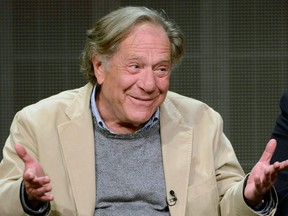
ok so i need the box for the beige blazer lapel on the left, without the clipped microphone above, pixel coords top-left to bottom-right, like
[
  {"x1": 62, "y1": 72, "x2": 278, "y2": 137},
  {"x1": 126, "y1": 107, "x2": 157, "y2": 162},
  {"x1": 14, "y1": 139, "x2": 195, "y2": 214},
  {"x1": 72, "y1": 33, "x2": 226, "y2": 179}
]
[{"x1": 58, "y1": 85, "x2": 96, "y2": 216}]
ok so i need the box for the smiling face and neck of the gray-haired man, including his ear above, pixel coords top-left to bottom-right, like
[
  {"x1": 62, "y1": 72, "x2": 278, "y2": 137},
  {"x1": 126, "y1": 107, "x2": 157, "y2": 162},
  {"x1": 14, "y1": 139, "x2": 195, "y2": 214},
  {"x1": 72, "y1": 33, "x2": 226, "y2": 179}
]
[{"x1": 93, "y1": 24, "x2": 171, "y2": 133}]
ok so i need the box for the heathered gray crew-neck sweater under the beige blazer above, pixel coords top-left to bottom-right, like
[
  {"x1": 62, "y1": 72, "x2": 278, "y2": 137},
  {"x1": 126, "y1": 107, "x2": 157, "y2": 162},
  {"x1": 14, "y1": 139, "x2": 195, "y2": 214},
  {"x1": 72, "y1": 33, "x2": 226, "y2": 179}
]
[{"x1": 94, "y1": 121, "x2": 169, "y2": 216}]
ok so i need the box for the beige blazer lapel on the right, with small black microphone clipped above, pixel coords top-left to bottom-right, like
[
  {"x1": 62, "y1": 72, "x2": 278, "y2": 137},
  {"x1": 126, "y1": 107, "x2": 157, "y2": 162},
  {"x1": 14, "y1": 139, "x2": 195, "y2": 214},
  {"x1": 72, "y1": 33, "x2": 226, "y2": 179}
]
[{"x1": 160, "y1": 100, "x2": 193, "y2": 216}]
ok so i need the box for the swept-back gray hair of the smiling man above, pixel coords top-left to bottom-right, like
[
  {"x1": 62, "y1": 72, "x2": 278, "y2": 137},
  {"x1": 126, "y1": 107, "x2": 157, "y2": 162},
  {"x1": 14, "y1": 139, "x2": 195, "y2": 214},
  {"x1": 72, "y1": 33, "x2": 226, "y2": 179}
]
[{"x1": 81, "y1": 6, "x2": 184, "y2": 84}]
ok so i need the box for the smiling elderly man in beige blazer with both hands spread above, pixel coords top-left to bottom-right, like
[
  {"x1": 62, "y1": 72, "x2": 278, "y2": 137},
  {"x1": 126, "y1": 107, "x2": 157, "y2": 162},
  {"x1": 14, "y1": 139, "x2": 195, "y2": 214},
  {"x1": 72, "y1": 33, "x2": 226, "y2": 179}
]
[{"x1": 0, "y1": 7, "x2": 288, "y2": 216}]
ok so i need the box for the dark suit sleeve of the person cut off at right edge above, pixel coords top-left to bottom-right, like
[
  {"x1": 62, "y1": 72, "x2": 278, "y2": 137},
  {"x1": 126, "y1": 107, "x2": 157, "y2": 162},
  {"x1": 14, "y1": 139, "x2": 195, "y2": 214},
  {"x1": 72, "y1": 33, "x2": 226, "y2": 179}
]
[{"x1": 271, "y1": 91, "x2": 288, "y2": 216}]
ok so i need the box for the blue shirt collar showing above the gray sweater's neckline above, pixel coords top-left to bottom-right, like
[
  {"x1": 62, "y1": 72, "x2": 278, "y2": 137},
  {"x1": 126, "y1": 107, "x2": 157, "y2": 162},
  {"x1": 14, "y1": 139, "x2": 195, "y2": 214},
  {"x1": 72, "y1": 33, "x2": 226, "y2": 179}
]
[{"x1": 90, "y1": 85, "x2": 160, "y2": 133}]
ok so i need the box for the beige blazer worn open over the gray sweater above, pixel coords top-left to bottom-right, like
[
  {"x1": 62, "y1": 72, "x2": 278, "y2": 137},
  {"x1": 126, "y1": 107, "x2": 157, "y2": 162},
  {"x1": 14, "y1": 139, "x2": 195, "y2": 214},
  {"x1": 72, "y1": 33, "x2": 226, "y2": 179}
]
[{"x1": 0, "y1": 84, "x2": 274, "y2": 216}]
